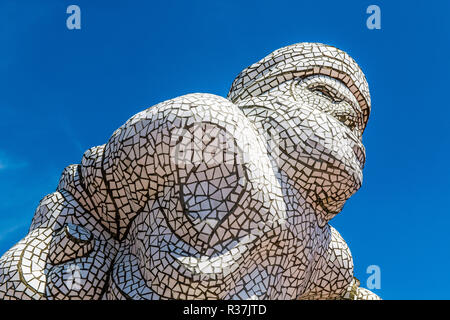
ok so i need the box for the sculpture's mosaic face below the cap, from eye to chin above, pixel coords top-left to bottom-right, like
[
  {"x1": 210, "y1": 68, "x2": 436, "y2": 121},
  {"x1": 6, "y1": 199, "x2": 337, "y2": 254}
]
[{"x1": 263, "y1": 75, "x2": 365, "y2": 221}]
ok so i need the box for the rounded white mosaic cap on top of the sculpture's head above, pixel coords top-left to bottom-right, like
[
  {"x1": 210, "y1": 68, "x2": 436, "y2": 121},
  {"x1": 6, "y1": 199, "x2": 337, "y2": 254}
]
[{"x1": 228, "y1": 42, "x2": 370, "y2": 129}]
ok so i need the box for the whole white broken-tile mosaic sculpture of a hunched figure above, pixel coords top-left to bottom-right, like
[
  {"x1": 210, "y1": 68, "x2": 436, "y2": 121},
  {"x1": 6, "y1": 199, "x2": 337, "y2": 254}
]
[{"x1": 0, "y1": 43, "x2": 379, "y2": 299}]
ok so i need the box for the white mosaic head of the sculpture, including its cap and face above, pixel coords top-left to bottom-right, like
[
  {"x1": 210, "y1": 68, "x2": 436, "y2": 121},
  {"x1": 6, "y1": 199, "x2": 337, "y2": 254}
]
[{"x1": 228, "y1": 43, "x2": 370, "y2": 223}]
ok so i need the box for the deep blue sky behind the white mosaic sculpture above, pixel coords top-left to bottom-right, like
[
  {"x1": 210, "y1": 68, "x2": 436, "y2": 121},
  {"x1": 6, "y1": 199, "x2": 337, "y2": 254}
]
[{"x1": 0, "y1": 0, "x2": 450, "y2": 299}]
